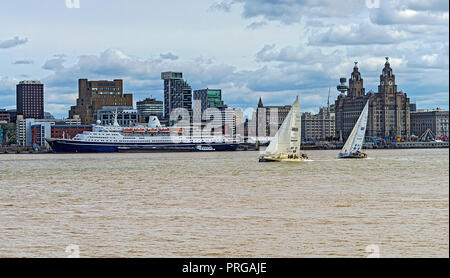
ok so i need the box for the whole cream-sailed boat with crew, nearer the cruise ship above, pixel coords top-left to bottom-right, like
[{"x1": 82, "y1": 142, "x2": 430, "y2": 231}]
[{"x1": 259, "y1": 96, "x2": 308, "y2": 162}]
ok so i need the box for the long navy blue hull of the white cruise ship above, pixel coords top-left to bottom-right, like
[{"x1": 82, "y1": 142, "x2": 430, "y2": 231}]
[{"x1": 46, "y1": 139, "x2": 239, "y2": 153}]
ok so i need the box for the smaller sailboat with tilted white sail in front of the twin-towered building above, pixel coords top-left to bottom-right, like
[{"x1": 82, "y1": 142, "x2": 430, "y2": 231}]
[{"x1": 338, "y1": 101, "x2": 369, "y2": 158}]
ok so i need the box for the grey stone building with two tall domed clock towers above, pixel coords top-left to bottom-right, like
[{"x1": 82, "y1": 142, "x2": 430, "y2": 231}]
[{"x1": 335, "y1": 57, "x2": 411, "y2": 140}]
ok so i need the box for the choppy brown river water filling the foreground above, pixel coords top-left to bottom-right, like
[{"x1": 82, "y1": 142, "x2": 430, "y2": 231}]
[{"x1": 0, "y1": 149, "x2": 449, "y2": 257}]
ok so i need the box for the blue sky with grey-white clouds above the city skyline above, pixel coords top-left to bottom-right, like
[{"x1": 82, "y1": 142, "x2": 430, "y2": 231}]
[{"x1": 0, "y1": 0, "x2": 449, "y2": 118}]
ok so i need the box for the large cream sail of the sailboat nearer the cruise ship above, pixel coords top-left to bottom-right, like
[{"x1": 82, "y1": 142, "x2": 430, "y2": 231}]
[{"x1": 265, "y1": 97, "x2": 301, "y2": 156}]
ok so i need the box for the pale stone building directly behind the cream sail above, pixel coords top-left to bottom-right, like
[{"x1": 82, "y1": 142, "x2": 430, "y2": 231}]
[{"x1": 255, "y1": 98, "x2": 291, "y2": 137}]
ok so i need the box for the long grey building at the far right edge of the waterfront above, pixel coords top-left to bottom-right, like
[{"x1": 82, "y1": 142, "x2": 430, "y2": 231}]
[{"x1": 411, "y1": 108, "x2": 449, "y2": 139}]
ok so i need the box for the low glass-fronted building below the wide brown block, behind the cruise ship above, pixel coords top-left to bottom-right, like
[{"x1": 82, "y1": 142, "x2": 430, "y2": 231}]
[{"x1": 94, "y1": 106, "x2": 140, "y2": 126}]
